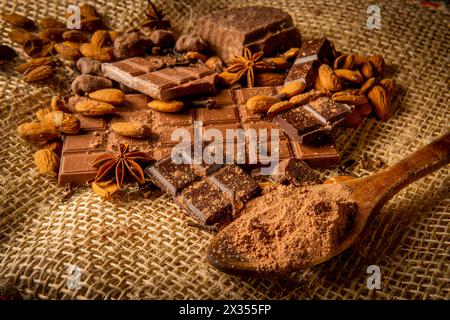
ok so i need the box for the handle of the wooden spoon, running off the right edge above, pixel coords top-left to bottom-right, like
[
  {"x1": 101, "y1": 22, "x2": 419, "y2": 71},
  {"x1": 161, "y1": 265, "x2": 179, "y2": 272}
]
[{"x1": 358, "y1": 132, "x2": 450, "y2": 208}]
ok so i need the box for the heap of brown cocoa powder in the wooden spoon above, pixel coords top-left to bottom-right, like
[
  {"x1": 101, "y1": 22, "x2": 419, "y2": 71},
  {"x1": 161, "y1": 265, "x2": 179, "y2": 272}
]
[{"x1": 222, "y1": 184, "x2": 357, "y2": 272}]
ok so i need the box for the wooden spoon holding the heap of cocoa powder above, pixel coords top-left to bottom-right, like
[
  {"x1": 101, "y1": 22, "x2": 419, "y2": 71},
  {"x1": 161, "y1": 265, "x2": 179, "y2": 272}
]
[{"x1": 207, "y1": 132, "x2": 450, "y2": 275}]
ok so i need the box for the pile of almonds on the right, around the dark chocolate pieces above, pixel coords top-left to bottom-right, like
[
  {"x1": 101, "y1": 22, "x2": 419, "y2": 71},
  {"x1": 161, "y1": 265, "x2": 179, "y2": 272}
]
[{"x1": 247, "y1": 49, "x2": 396, "y2": 128}]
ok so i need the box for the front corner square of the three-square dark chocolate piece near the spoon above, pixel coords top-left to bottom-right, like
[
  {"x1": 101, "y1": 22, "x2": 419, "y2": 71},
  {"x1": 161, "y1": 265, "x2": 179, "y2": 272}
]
[{"x1": 176, "y1": 179, "x2": 233, "y2": 224}]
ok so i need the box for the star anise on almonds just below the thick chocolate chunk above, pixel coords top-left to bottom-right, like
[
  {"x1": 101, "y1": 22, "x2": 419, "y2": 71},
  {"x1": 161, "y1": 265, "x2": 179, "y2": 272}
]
[{"x1": 226, "y1": 48, "x2": 273, "y2": 88}]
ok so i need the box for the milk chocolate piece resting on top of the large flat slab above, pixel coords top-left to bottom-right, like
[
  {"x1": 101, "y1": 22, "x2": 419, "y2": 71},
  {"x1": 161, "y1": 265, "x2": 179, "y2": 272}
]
[{"x1": 102, "y1": 57, "x2": 216, "y2": 100}]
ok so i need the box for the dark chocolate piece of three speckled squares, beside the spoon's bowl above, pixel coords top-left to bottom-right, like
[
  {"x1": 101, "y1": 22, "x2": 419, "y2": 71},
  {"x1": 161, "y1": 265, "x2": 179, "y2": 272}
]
[{"x1": 145, "y1": 156, "x2": 259, "y2": 225}]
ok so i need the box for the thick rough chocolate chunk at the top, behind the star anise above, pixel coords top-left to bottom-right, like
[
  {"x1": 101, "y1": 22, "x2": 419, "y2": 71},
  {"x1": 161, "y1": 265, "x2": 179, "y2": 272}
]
[{"x1": 195, "y1": 6, "x2": 301, "y2": 62}]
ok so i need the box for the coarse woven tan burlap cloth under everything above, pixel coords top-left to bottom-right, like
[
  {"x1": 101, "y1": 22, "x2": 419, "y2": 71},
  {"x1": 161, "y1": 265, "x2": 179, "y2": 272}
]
[{"x1": 0, "y1": 0, "x2": 450, "y2": 299}]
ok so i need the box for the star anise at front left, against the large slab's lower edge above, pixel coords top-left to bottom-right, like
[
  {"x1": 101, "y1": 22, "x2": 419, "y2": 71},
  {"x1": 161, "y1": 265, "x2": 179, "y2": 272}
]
[{"x1": 91, "y1": 143, "x2": 152, "y2": 189}]
